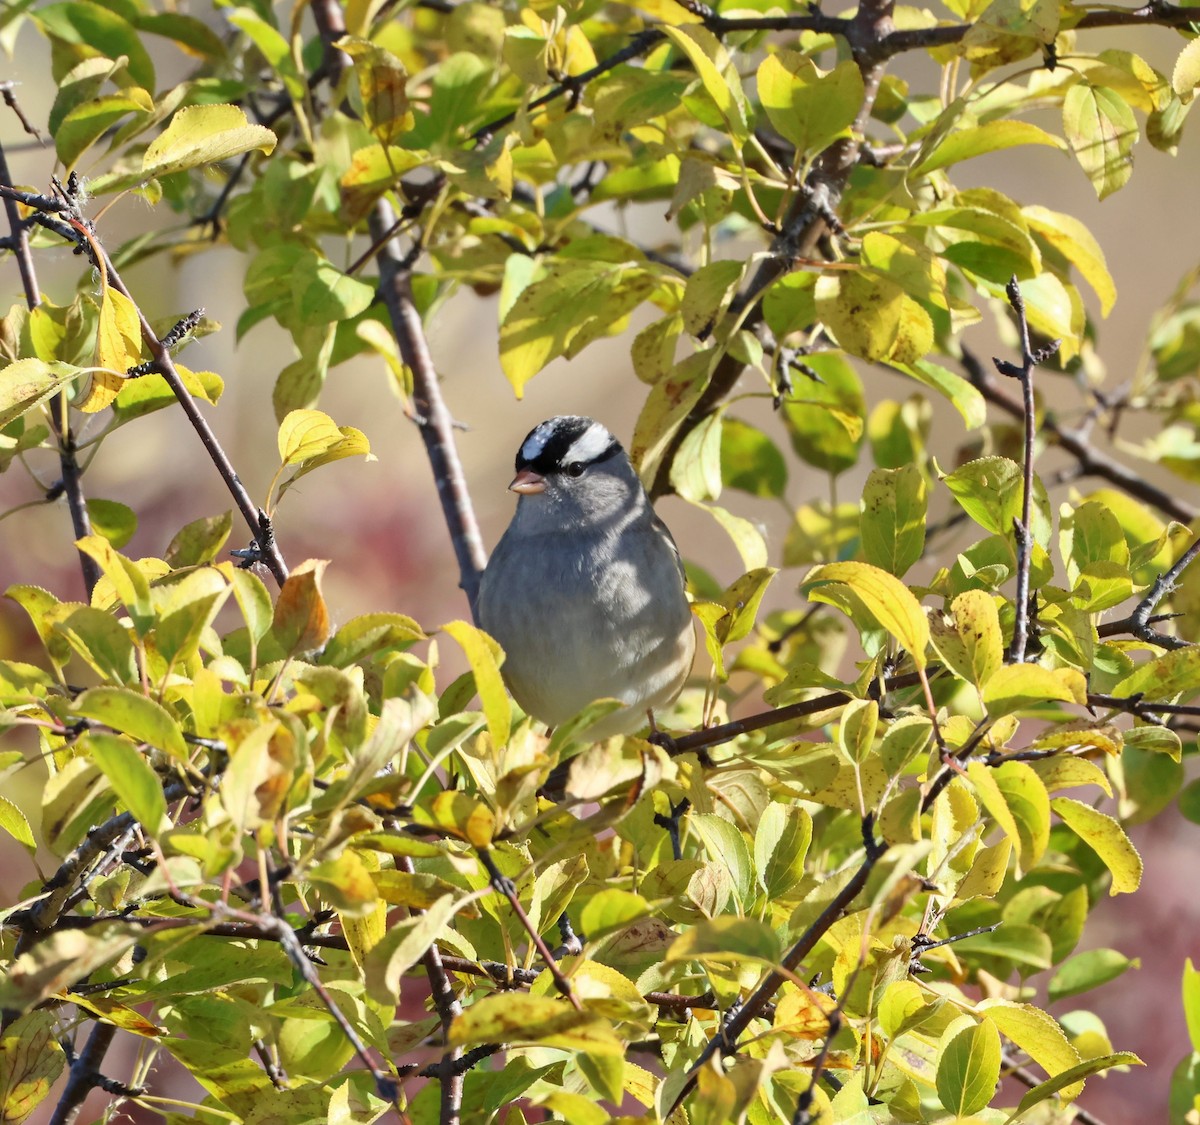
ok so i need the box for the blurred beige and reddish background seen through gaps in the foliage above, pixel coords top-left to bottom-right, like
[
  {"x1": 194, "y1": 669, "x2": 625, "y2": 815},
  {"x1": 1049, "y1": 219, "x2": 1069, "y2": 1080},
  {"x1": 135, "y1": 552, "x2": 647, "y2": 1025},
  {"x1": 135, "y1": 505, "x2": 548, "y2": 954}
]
[{"x1": 0, "y1": 6, "x2": 1200, "y2": 1123}]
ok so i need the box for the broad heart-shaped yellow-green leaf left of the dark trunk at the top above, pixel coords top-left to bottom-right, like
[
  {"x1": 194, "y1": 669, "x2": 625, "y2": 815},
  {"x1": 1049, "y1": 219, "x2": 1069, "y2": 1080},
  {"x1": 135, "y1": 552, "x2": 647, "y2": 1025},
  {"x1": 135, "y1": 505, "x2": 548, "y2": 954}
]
[{"x1": 757, "y1": 50, "x2": 863, "y2": 155}]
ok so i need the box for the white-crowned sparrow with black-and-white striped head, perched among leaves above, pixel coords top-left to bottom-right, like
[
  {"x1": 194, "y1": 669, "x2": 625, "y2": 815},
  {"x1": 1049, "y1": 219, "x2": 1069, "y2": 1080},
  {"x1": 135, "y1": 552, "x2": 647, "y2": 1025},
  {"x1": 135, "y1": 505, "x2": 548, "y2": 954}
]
[{"x1": 479, "y1": 415, "x2": 696, "y2": 739}]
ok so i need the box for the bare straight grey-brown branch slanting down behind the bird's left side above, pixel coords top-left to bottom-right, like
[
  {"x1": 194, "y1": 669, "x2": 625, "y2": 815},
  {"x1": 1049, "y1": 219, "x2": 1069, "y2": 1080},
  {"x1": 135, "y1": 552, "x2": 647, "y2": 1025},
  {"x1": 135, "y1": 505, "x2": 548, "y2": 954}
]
[{"x1": 371, "y1": 200, "x2": 487, "y2": 616}]
